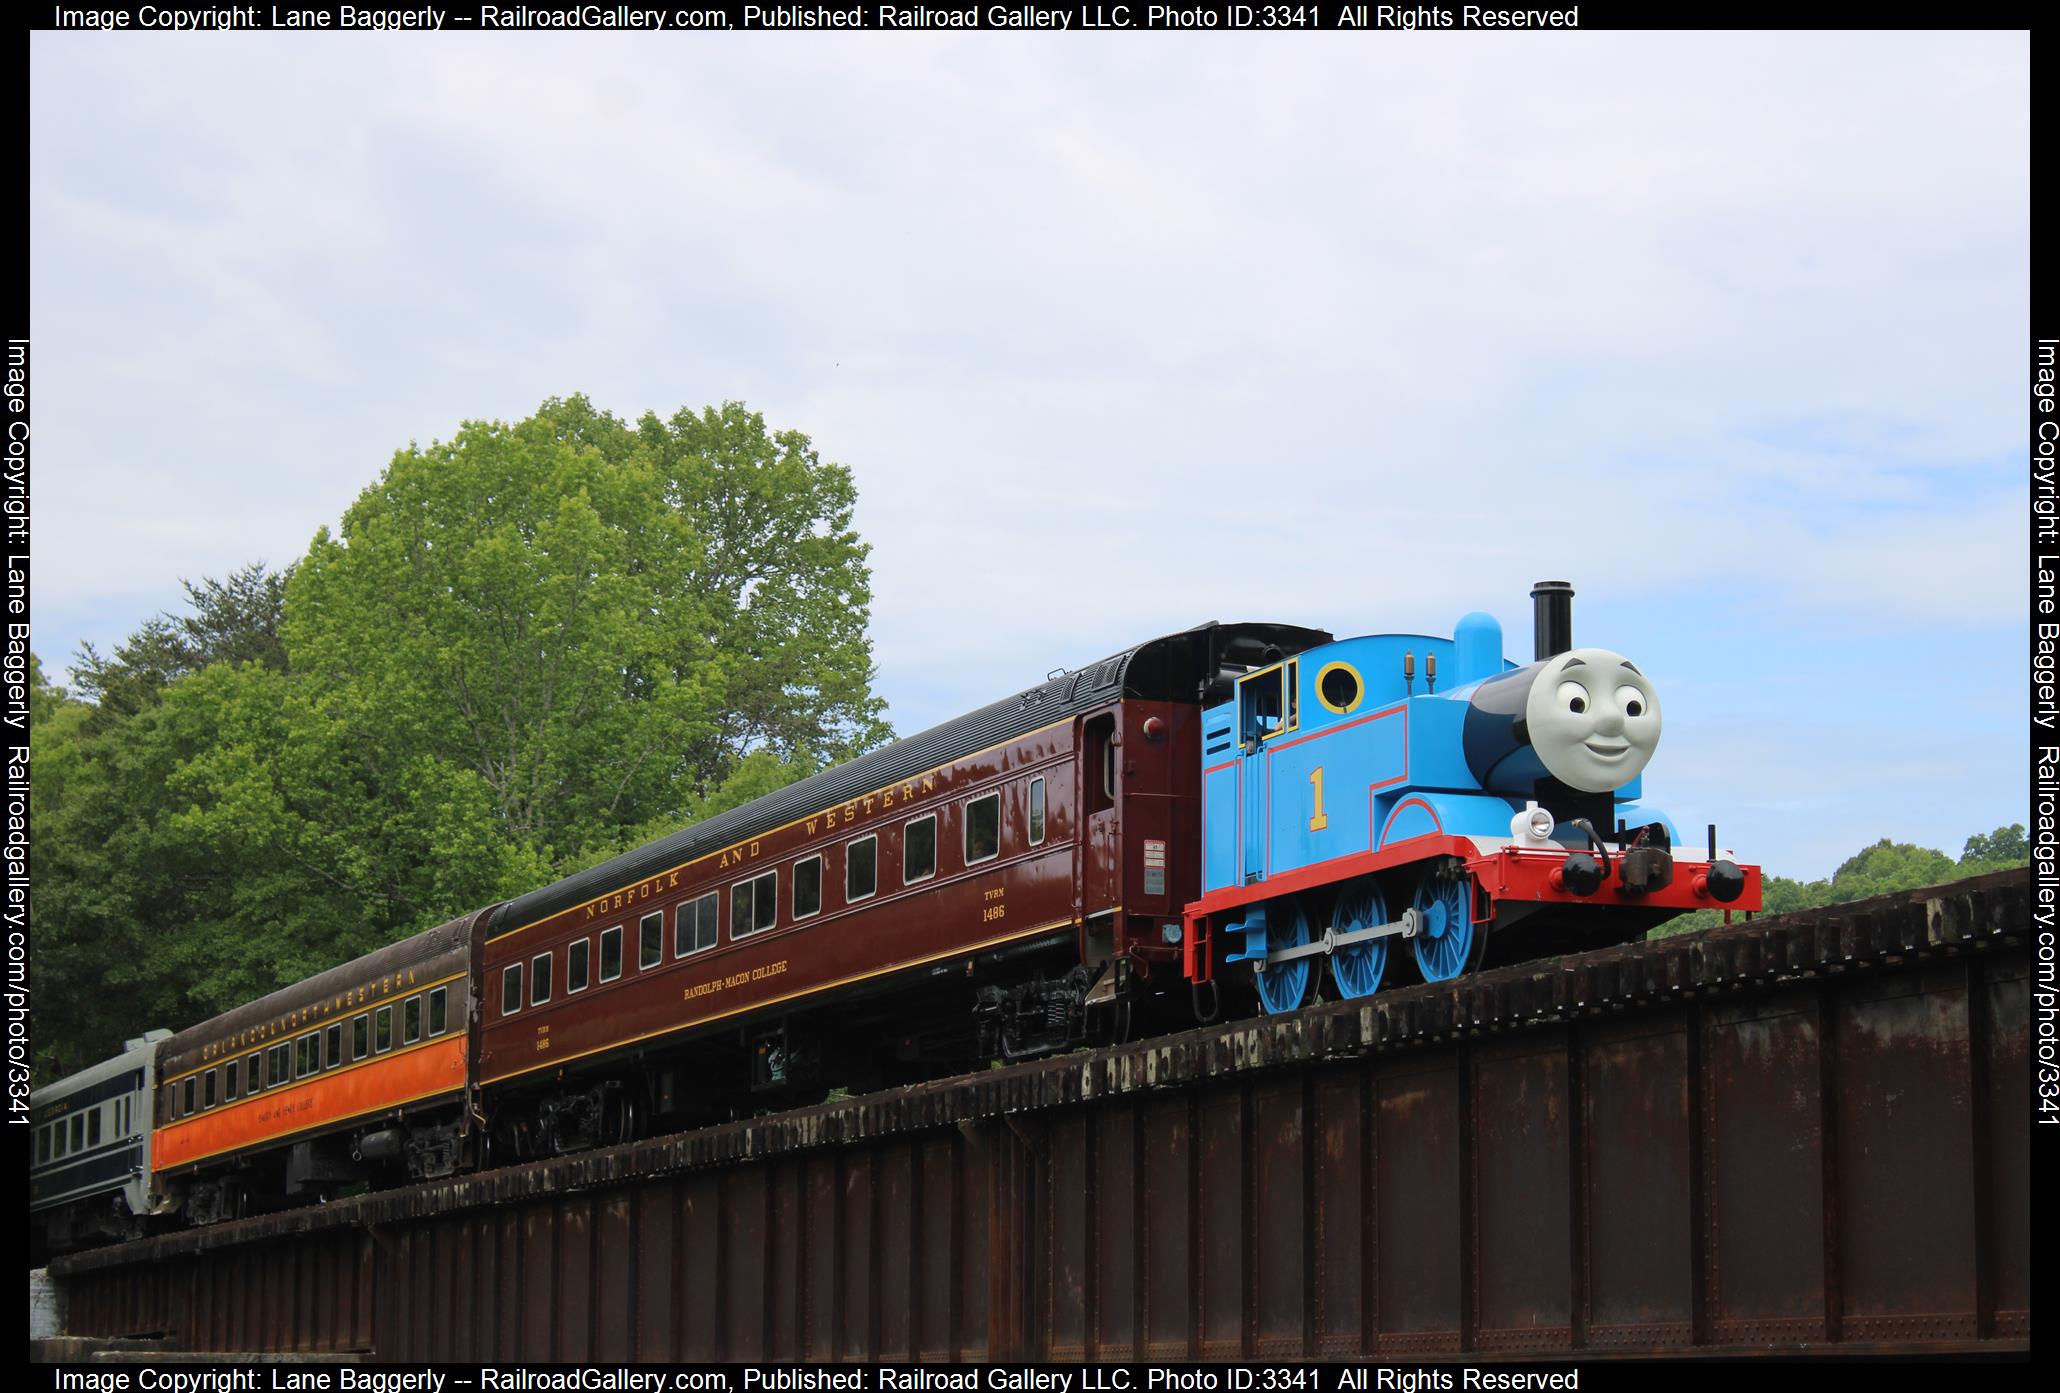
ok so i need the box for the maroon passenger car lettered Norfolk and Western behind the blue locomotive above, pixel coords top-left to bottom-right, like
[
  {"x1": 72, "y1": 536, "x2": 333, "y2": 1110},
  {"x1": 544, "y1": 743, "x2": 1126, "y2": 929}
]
[{"x1": 474, "y1": 624, "x2": 1329, "y2": 1154}]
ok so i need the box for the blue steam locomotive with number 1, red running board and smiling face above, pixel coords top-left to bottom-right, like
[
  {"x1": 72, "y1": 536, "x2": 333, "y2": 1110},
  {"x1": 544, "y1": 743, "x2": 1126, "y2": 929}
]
[{"x1": 1182, "y1": 581, "x2": 1759, "y2": 1012}]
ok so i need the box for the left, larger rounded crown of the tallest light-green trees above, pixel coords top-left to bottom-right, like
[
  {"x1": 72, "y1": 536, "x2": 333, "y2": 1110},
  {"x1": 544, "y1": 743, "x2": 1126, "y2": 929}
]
[{"x1": 286, "y1": 398, "x2": 723, "y2": 863}]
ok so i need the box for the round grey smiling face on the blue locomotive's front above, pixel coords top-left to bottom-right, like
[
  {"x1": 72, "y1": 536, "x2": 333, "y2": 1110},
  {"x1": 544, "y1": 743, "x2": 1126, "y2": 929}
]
[{"x1": 1524, "y1": 649, "x2": 1660, "y2": 793}]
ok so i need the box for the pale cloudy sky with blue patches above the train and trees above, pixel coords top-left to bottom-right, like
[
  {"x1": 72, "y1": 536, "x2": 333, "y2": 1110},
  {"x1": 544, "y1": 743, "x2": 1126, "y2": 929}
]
[{"x1": 29, "y1": 33, "x2": 2029, "y2": 878}]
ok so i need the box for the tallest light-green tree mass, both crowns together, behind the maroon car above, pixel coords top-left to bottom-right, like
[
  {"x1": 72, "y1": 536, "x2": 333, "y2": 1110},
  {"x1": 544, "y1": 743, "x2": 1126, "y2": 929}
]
[{"x1": 286, "y1": 396, "x2": 886, "y2": 868}]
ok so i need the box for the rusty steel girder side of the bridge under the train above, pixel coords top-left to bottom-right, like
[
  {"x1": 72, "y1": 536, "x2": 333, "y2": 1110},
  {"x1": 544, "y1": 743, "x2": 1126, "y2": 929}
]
[{"x1": 52, "y1": 872, "x2": 2031, "y2": 1360}]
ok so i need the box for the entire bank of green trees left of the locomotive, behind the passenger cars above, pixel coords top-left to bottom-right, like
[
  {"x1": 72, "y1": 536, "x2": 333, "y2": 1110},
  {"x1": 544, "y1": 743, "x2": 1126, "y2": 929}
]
[{"x1": 31, "y1": 396, "x2": 888, "y2": 1078}]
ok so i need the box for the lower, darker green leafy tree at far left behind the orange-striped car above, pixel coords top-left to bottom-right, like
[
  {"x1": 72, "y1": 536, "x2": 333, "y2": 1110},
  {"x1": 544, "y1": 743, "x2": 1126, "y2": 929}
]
[{"x1": 33, "y1": 664, "x2": 546, "y2": 1072}]
